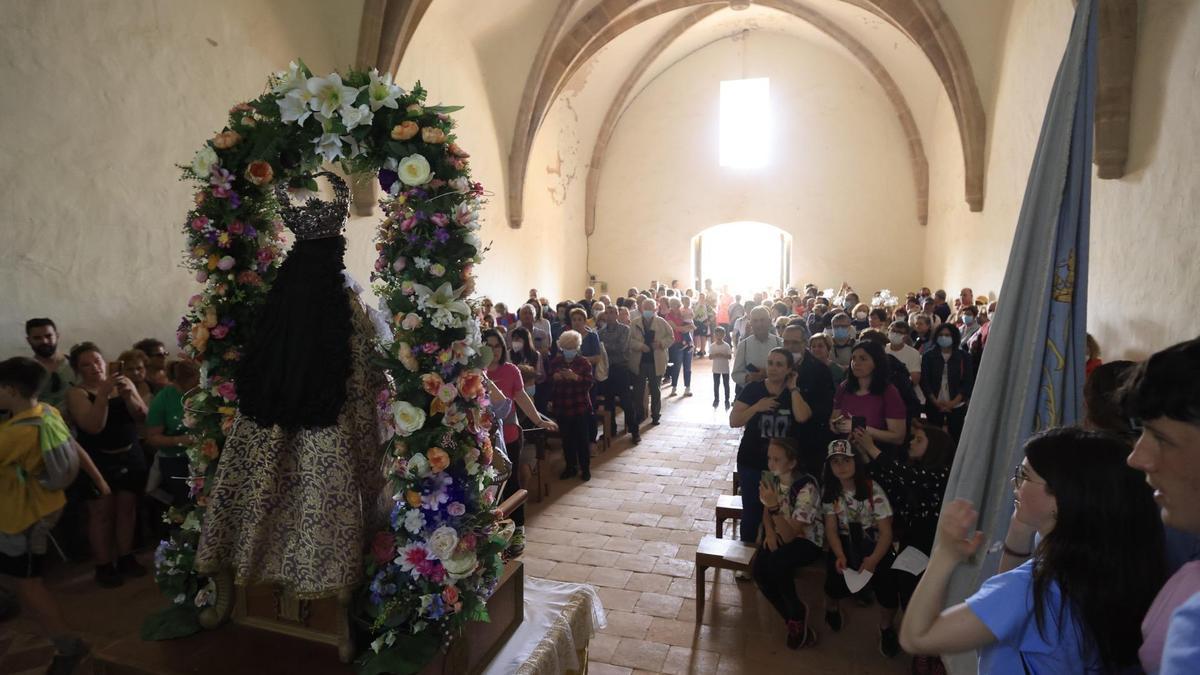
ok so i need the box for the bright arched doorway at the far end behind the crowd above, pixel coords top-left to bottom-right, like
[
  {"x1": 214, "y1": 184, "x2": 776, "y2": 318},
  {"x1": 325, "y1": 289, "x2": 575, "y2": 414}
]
[{"x1": 691, "y1": 221, "x2": 792, "y2": 297}]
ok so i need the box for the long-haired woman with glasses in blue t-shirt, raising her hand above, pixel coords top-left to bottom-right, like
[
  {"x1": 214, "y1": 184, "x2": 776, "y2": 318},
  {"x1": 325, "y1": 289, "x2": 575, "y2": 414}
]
[{"x1": 900, "y1": 428, "x2": 1165, "y2": 675}]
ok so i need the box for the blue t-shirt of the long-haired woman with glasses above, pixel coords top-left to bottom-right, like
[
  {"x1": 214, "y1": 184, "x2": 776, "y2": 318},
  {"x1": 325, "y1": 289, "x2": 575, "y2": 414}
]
[{"x1": 967, "y1": 560, "x2": 1103, "y2": 675}]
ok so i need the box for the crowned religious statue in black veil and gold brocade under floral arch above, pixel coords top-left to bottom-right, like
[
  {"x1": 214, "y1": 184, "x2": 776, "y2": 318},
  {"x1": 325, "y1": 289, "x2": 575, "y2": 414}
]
[{"x1": 197, "y1": 172, "x2": 391, "y2": 599}]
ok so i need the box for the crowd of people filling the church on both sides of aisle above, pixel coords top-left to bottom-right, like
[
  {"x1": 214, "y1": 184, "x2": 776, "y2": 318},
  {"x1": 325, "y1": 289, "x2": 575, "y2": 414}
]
[{"x1": 0, "y1": 276, "x2": 1200, "y2": 673}]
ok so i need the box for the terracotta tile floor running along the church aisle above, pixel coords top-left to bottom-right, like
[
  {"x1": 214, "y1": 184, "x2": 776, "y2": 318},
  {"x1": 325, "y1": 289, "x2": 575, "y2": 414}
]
[{"x1": 0, "y1": 360, "x2": 908, "y2": 675}]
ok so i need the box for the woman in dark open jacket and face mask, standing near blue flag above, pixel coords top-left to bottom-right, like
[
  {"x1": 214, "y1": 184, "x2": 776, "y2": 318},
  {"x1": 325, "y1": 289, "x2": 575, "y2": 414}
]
[{"x1": 920, "y1": 323, "x2": 974, "y2": 443}]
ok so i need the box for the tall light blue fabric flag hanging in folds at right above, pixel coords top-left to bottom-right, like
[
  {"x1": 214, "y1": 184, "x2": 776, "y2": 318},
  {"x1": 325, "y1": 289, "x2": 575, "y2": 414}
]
[{"x1": 946, "y1": 0, "x2": 1097, "y2": 673}]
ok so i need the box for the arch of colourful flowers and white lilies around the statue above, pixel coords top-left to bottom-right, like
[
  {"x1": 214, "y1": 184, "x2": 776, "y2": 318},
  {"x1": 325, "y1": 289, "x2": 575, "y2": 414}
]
[{"x1": 156, "y1": 61, "x2": 504, "y2": 671}]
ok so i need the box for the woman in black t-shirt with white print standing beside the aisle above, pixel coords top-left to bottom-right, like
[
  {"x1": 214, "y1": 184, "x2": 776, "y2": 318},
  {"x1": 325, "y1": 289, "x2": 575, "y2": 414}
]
[{"x1": 730, "y1": 347, "x2": 812, "y2": 557}]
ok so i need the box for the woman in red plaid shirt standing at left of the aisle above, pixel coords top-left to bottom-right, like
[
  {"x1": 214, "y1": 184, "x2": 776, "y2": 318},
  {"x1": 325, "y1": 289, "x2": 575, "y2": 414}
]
[{"x1": 547, "y1": 330, "x2": 593, "y2": 480}]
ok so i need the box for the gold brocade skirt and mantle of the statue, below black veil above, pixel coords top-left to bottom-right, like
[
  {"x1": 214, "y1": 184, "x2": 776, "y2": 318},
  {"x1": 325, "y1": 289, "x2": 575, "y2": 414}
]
[{"x1": 196, "y1": 297, "x2": 390, "y2": 598}]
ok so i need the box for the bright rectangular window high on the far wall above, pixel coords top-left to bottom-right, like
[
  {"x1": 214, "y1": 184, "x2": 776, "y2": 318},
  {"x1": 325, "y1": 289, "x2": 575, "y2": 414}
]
[{"x1": 720, "y1": 77, "x2": 770, "y2": 168}]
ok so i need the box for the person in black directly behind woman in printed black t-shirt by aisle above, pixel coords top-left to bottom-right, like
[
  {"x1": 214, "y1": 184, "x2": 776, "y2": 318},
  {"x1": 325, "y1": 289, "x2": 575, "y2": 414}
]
[{"x1": 784, "y1": 319, "x2": 834, "y2": 477}]
